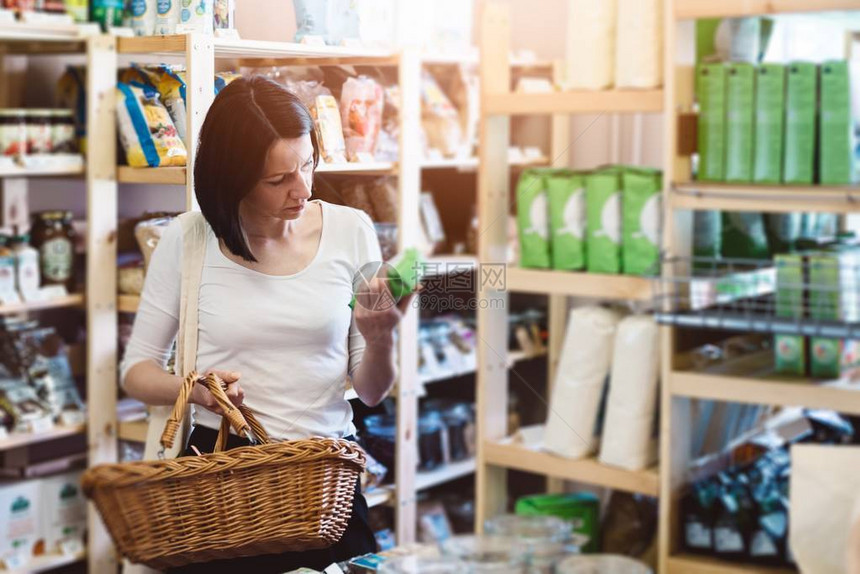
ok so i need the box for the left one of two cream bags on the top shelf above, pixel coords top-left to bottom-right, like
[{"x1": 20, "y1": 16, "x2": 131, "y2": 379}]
[{"x1": 565, "y1": 0, "x2": 616, "y2": 90}]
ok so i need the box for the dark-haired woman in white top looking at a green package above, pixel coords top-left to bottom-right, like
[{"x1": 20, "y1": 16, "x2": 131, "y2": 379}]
[{"x1": 121, "y1": 77, "x2": 412, "y2": 572}]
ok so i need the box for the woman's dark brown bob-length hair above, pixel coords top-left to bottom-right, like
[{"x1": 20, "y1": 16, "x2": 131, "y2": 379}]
[{"x1": 194, "y1": 76, "x2": 319, "y2": 262}]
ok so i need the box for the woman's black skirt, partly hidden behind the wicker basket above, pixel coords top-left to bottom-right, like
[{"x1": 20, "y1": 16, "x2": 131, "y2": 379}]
[{"x1": 168, "y1": 426, "x2": 376, "y2": 574}]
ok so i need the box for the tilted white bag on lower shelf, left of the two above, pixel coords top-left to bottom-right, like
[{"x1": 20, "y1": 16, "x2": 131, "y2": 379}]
[{"x1": 544, "y1": 307, "x2": 620, "y2": 458}]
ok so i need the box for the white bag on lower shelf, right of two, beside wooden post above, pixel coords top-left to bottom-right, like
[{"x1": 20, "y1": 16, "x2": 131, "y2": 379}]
[{"x1": 600, "y1": 315, "x2": 660, "y2": 470}]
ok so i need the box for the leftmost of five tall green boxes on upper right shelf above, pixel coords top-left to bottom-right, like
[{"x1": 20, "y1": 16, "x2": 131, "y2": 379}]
[{"x1": 696, "y1": 64, "x2": 726, "y2": 181}]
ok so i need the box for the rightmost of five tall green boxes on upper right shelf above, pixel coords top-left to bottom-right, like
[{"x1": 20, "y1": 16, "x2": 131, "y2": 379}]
[{"x1": 818, "y1": 60, "x2": 854, "y2": 185}]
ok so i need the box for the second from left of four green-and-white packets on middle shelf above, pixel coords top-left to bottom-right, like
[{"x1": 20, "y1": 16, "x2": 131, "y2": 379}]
[{"x1": 544, "y1": 170, "x2": 586, "y2": 271}]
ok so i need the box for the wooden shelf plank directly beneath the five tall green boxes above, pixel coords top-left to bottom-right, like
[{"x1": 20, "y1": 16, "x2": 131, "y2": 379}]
[{"x1": 670, "y1": 182, "x2": 860, "y2": 213}]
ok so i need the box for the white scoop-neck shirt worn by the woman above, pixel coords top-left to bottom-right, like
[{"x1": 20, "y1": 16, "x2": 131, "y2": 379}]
[{"x1": 121, "y1": 201, "x2": 382, "y2": 439}]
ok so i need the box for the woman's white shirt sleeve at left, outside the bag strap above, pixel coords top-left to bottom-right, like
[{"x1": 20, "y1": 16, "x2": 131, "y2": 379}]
[{"x1": 120, "y1": 220, "x2": 182, "y2": 392}]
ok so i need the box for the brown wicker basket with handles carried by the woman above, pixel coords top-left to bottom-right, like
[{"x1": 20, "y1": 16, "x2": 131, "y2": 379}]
[{"x1": 83, "y1": 373, "x2": 365, "y2": 570}]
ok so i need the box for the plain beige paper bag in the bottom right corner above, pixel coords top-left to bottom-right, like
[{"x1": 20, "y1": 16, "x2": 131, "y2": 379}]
[{"x1": 788, "y1": 444, "x2": 860, "y2": 574}]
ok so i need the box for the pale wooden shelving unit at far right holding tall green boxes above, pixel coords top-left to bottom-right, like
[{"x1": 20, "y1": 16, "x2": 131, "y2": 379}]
[{"x1": 659, "y1": 0, "x2": 860, "y2": 574}]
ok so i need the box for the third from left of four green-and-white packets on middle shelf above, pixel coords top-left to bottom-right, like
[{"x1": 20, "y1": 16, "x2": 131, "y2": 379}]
[{"x1": 585, "y1": 166, "x2": 623, "y2": 274}]
